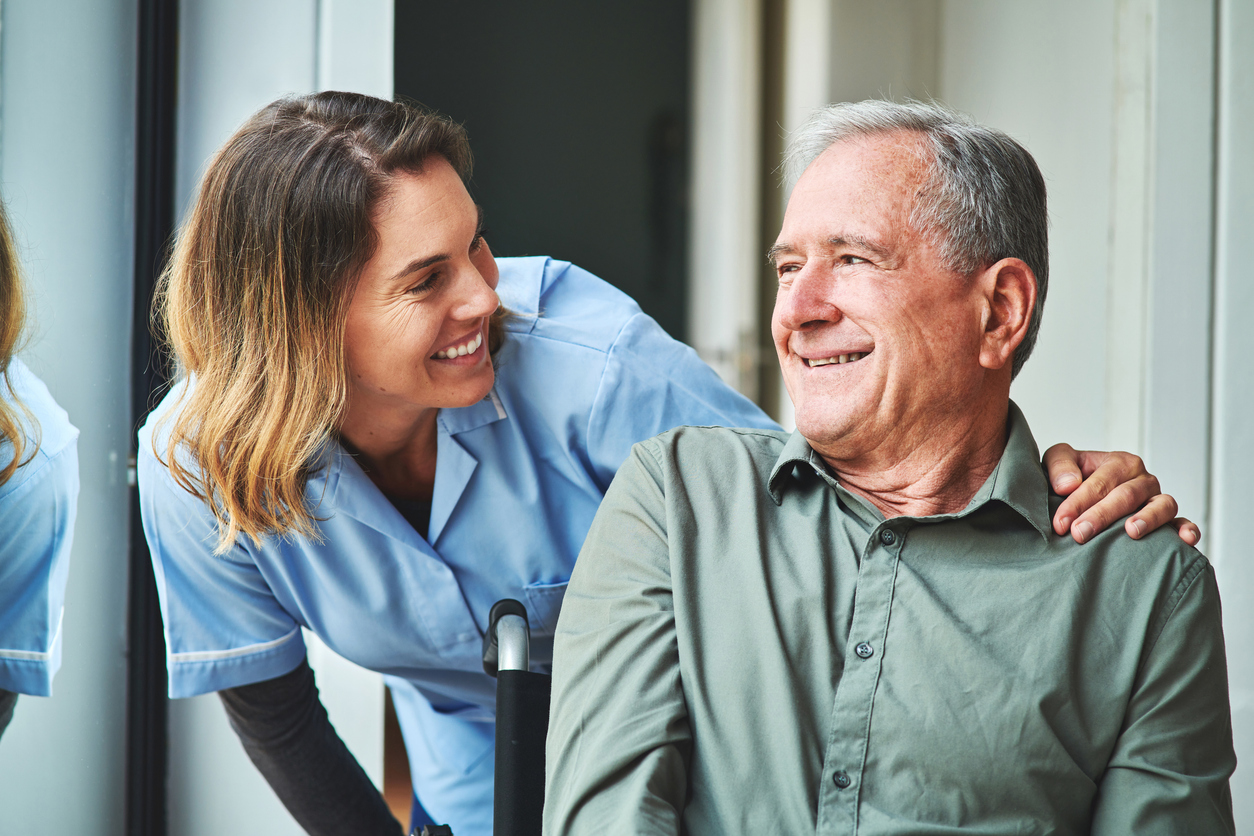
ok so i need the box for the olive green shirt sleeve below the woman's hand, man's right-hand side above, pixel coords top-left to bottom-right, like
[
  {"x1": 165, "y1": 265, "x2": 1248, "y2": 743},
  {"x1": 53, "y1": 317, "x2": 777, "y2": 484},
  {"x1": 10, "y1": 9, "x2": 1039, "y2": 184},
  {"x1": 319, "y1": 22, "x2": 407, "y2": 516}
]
[{"x1": 1092, "y1": 555, "x2": 1236, "y2": 836}]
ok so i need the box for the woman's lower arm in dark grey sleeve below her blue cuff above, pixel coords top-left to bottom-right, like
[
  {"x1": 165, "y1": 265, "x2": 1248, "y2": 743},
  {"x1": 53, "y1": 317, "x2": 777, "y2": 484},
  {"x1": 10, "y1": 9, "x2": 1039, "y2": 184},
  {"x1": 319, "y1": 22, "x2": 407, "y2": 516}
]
[{"x1": 218, "y1": 661, "x2": 403, "y2": 836}]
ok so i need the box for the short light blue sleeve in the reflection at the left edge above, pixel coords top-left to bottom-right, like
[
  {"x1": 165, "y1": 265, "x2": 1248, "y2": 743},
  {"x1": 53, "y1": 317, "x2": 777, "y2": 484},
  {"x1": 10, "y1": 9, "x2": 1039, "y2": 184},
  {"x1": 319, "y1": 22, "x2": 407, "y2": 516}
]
[{"x1": 0, "y1": 441, "x2": 79, "y2": 697}]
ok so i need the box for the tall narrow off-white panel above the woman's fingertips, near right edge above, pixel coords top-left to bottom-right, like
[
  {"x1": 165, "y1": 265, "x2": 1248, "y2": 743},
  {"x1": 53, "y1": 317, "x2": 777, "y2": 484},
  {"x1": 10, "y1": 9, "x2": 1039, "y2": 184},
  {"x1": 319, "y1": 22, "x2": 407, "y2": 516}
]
[{"x1": 1144, "y1": 0, "x2": 1213, "y2": 543}]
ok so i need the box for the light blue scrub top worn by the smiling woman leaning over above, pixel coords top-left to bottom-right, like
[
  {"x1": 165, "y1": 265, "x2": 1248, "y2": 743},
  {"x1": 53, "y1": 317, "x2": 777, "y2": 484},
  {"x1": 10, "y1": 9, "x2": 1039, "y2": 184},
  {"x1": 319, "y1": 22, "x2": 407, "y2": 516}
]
[{"x1": 138, "y1": 257, "x2": 775, "y2": 836}]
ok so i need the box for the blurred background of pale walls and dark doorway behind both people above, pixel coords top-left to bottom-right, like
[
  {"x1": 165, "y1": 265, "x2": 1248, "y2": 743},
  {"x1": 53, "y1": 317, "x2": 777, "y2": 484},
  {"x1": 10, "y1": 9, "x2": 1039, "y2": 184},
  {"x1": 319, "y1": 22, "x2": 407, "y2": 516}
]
[{"x1": 0, "y1": 0, "x2": 1254, "y2": 836}]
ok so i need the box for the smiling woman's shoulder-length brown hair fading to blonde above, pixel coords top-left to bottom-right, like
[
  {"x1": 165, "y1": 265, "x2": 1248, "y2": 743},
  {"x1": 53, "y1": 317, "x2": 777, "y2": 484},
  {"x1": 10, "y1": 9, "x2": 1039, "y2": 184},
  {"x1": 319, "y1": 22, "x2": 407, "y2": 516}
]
[{"x1": 154, "y1": 93, "x2": 504, "y2": 551}]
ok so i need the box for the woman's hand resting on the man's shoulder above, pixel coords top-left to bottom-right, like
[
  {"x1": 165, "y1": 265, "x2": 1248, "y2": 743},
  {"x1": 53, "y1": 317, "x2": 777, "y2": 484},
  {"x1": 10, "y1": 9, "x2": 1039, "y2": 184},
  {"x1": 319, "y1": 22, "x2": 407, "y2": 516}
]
[{"x1": 1045, "y1": 444, "x2": 1201, "y2": 545}]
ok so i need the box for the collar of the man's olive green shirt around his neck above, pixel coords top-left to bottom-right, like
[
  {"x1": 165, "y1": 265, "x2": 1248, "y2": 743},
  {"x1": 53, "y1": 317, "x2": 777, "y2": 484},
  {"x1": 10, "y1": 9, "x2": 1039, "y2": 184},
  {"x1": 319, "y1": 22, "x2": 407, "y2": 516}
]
[{"x1": 766, "y1": 401, "x2": 1053, "y2": 539}]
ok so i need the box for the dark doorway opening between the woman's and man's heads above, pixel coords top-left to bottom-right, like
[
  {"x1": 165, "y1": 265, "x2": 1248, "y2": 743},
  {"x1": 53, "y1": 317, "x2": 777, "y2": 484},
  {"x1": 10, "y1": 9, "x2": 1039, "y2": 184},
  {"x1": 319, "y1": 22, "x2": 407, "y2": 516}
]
[{"x1": 395, "y1": 0, "x2": 691, "y2": 340}]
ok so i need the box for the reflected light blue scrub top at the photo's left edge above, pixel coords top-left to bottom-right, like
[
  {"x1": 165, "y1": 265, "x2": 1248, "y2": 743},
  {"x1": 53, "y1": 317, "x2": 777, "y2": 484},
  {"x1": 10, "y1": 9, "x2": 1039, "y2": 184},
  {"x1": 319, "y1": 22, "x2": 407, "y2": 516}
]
[{"x1": 0, "y1": 360, "x2": 79, "y2": 697}]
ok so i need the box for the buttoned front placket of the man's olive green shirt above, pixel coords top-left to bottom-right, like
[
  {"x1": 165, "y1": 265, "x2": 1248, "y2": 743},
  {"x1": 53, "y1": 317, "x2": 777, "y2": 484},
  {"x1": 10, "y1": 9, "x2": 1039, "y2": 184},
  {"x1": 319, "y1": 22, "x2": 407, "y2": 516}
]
[{"x1": 816, "y1": 523, "x2": 904, "y2": 836}]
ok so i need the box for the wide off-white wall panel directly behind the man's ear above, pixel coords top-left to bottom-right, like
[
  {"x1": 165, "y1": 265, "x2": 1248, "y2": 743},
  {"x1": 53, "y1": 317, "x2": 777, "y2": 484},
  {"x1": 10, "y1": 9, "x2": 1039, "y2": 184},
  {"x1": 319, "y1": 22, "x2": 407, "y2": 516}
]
[{"x1": 935, "y1": 0, "x2": 1123, "y2": 458}]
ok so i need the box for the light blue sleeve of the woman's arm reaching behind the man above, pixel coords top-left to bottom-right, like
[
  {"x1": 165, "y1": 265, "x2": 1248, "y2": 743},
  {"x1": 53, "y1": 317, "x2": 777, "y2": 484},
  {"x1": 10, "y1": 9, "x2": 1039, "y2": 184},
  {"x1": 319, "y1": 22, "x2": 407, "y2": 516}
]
[{"x1": 587, "y1": 313, "x2": 780, "y2": 490}]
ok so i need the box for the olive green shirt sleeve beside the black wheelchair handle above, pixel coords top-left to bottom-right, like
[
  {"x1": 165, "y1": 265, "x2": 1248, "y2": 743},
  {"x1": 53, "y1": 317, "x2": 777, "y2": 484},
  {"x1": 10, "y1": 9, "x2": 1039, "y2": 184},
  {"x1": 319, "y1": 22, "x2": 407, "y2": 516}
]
[{"x1": 544, "y1": 445, "x2": 691, "y2": 836}]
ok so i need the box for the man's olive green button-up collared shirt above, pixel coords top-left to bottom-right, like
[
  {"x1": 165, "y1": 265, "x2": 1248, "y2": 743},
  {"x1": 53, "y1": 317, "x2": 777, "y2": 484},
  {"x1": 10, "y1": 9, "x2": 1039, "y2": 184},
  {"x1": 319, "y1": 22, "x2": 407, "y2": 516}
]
[{"x1": 544, "y1": 404, "x2": 1235, "y2": 836}]
